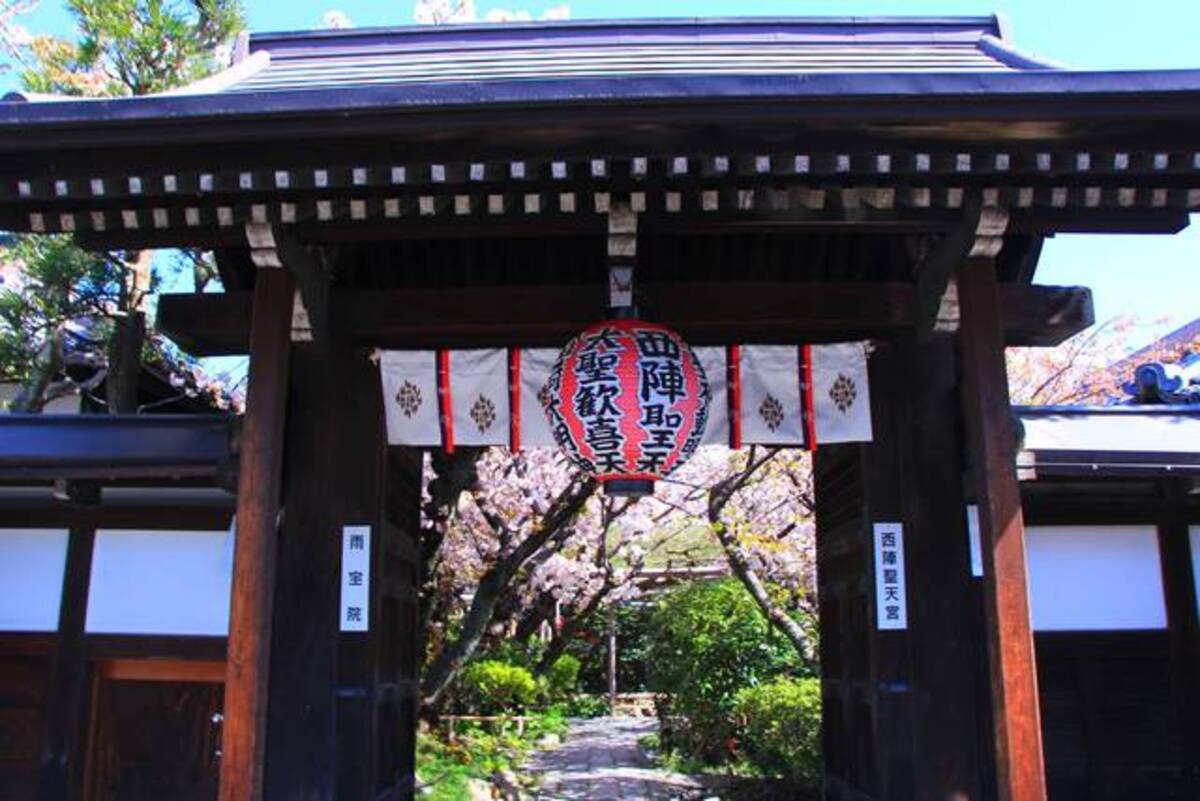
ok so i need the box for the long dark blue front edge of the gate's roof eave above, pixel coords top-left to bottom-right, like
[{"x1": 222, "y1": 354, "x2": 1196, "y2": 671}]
[{"x1": 7, "y1": 70, "x2": 1200, "y2": 133}]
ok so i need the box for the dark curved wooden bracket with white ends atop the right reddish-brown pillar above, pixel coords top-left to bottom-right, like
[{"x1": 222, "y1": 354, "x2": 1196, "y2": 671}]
[{"x1": 916, "y1": 199, "x2": 1008, "y2": 338}]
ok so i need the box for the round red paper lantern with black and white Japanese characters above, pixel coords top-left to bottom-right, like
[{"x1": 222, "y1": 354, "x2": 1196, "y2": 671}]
[{"x1": 541, "y1": 320, "x2": 709, "y2": 494}]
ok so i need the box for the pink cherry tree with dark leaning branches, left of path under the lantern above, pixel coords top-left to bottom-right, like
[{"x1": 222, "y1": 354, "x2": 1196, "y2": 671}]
[{"x1": 421, "y1": 448, "x2": 744, "y2": 707}]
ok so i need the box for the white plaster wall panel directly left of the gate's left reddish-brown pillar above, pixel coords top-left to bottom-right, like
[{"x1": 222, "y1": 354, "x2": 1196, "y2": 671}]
[{"x1": 86, "y1": 530, "x2": 233, "y2": 636}]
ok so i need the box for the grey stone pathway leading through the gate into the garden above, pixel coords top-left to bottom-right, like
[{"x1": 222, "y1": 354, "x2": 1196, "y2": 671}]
[{"x1": 524, "y1": 717, "x2": 709, "y2": 801}]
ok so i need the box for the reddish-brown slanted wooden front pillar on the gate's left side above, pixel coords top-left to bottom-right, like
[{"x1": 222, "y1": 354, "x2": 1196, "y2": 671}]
[{"x1": 220, "y1": 269, "x2": 295, "y2": 801}]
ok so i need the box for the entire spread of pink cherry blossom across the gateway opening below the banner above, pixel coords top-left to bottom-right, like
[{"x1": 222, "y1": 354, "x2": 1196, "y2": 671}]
[{"x1": 422, "y1": 448, "x2": 816, "y2": 707}]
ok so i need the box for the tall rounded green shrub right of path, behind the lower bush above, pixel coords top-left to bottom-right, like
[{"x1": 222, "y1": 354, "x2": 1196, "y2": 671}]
[{"x1": 649, "y1": 579, "x2": 799, "y2": 763}]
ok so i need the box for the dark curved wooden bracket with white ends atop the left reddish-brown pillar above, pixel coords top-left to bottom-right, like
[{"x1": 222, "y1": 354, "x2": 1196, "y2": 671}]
[{"x1": 246, "y1": 223, "x2": 332, "y2": 343}]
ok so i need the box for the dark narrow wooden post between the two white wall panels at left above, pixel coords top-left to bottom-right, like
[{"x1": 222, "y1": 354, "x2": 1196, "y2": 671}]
[{"x1": 37, "y1": 489, "x2": 100, "y2": 801}]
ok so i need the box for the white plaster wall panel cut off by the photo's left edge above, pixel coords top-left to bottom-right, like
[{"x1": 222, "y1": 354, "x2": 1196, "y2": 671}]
[{"x1": 0, "y1": 529, "x2": 68, "y2": 632}]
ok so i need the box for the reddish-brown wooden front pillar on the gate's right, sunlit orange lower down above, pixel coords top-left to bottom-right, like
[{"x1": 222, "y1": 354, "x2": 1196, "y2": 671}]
[{"x1": 959, "y1": 258, "x2": 1046, "y2": 801}]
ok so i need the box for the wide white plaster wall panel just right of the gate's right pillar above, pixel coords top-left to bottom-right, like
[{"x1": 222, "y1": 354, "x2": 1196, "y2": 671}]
[{"x1": 1025, "y1": 525, "x2": 1166, "y2": 631}]
